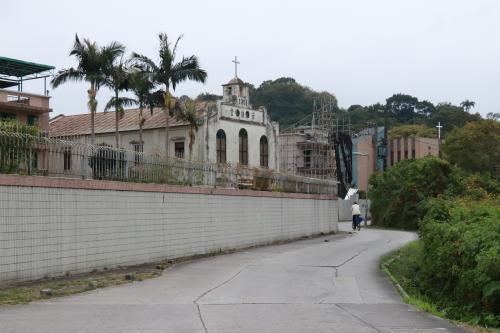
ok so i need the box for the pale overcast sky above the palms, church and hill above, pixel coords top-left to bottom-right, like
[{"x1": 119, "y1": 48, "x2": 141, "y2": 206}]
[{"x1": 0, "y1": 0, "x2": 500, "y2": 116}]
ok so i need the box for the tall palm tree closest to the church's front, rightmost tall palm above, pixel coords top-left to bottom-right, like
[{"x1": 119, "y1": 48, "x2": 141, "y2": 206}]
[{"x1": 132, "y1": 33, "x2": 207, "y2": 156}]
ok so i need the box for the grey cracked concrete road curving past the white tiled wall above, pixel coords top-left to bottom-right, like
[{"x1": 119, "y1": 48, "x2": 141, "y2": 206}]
[{"x1": 0, "y1": 223, "x2": 464, "y2": 333}]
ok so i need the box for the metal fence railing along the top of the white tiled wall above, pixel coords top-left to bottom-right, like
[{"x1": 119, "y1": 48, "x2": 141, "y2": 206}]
[{"x1": 0, "y1": 130, "x2": 337, "y2": 195}]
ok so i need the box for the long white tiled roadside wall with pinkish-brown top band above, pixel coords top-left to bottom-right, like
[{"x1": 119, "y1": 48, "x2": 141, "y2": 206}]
[{"x1": 0, "y1": 175, "x2": 338, "y2": 285}]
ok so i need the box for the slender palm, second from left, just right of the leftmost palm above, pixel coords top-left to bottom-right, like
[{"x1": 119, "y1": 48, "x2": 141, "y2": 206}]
[{"x1": 103, "y1": 59, "x2": 135, "y2": 148}]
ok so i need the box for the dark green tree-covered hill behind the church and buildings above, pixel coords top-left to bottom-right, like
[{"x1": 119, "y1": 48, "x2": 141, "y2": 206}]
[{"x1": 200, "y1": 77, "x2": 484, "y2": 135}]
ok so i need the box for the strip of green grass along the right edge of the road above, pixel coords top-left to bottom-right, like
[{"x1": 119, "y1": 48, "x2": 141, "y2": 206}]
[{"x1": 380, "y1": 240, "x2": 500, "y2": 333}]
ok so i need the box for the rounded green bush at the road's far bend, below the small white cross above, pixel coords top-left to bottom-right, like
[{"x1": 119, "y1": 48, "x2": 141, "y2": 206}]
[{"x1": 369, "y1": 156, "x2": 454, "y2": 230}]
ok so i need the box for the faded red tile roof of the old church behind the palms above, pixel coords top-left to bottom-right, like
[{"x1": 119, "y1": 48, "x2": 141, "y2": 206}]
[{"x1": 49, "y1": 102, "x2": 213, "y2": 137}]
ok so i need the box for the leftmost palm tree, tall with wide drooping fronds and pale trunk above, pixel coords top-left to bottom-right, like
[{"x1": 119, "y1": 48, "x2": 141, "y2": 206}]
[{"x1": 51, "y1": 35, "x2": 125, "y2": 144}]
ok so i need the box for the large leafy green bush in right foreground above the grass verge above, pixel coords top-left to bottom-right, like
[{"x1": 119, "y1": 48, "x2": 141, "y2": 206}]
[{"x1": 415, "y1": 198, "x2": 500, "y2": 327}]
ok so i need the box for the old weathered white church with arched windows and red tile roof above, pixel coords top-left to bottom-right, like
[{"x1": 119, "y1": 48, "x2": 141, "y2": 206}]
[{"x1": 49, "y1": 77, "x2": 279, "y2": 171}]
